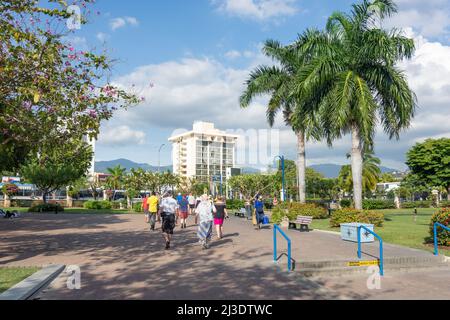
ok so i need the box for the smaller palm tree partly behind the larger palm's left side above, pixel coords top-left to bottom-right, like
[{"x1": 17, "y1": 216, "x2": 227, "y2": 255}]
[{"x1": 240, "y1": 40, "x2": 320, "y2": 203}]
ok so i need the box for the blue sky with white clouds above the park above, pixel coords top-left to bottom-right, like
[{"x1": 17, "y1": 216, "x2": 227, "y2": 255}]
[{"x1": 70, "y1": 0, "x2": 450, "y2": 170}]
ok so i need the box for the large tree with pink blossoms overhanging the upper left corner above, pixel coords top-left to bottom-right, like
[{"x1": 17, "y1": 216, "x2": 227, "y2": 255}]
[{"x1": 0, "y1": 0, "x2": 140, "y2": 171}]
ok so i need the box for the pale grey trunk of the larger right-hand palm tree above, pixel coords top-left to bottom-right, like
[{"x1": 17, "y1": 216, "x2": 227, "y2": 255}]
[{"x1": 352, "y1": 125, "x2": 363, "y2": 210}]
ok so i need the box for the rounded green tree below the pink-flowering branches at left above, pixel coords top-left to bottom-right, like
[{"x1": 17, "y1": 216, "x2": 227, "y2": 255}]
[{"x1": 21, "y1": 140, "x2": 92, "y2": 203}]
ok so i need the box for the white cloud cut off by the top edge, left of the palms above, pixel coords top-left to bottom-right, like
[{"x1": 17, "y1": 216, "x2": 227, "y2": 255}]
[{"x1": 213, "y1": 0, "x2": 298, "y2": 20}]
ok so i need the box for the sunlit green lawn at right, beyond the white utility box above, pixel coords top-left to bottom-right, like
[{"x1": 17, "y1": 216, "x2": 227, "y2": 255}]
[{"x1": 312, "y1": 209, "x2": 450, "y2": 256}]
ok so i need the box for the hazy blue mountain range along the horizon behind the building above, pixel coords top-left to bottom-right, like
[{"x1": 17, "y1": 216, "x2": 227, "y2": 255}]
[{"x1": 95, "y1": 159, "x2": 398, "y2": 178}]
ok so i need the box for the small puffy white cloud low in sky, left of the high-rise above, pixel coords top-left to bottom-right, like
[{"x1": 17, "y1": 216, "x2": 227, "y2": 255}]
[{"x1": 98, "y1": 125, "x2": 146, "y2": 147}]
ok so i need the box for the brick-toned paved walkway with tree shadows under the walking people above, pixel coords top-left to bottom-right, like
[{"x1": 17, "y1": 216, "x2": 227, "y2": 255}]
[{"x1": 0, "y1": 215, "x2": 450, "y2": 300}]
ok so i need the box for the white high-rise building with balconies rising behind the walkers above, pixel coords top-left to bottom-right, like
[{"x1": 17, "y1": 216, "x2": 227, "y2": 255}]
[{"x1": 169, "y1": 122, "x2": 239, "y2": 182}]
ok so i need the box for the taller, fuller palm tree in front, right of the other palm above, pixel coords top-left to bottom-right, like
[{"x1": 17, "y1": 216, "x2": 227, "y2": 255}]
[{"x1": 296, "y1": 0, "x2": 417, "y2": 209}]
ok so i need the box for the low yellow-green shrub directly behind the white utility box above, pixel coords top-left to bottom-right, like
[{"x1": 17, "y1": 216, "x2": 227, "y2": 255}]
[{"x1": 330, "y1": 208, "x2": 384, "y2": 228}]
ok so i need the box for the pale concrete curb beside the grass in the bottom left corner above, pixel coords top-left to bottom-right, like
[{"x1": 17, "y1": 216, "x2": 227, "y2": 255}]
[{"x1": 0, "y1": 264, "x2": 66, "y2": 300}]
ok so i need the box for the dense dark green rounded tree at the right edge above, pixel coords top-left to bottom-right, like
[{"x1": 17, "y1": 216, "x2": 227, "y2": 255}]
[{"x1": 406, "y1": 138, "x2": 450, "y2": 200}]
